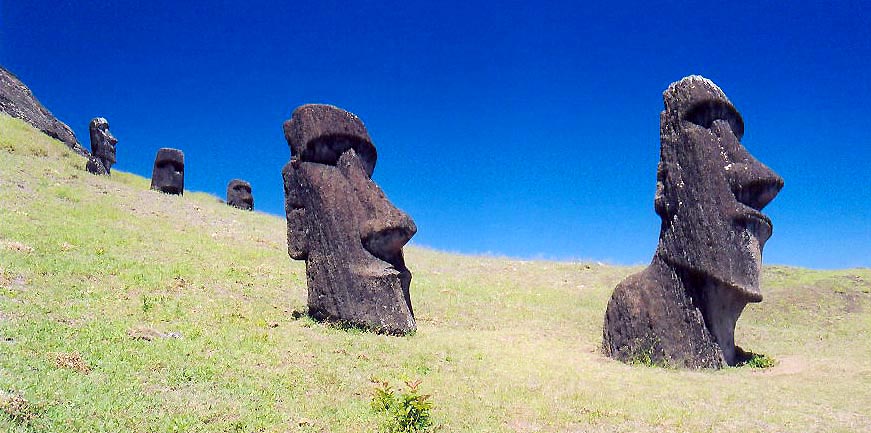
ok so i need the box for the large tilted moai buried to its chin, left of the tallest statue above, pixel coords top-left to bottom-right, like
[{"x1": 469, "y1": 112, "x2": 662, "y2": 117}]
[{"x1": 282, "y1": 105, "x2": 417, "y2": 334}]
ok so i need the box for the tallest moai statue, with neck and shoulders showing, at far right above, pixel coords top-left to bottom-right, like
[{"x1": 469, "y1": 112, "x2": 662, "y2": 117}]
[{"x1": 603, "y1": 76, "x2": 783, "y2": 368}]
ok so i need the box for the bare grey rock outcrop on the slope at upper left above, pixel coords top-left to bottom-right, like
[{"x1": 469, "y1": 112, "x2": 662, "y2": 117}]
[{"x1": 0, "y1": 66, "x2": 88, "y2": 157}]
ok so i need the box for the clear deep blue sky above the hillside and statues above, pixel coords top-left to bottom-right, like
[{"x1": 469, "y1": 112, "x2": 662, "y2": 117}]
[{"x1": 0, "y1": 0, "x2": 871, "y2": 268}]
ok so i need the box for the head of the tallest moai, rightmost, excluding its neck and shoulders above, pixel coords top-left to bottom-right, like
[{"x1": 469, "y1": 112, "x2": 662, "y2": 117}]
[{"x1": 654, "y1": 75, "x2": 783, "y2": 302}]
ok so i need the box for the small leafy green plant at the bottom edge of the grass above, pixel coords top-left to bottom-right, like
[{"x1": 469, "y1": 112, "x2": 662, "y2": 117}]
[{"x1": 372, "y1": 380, "x2": 432, "y2": 433}]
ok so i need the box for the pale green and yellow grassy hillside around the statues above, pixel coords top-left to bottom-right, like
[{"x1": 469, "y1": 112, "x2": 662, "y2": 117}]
[{"x1": 0, "y1": 115, "x2": 871, "y2": 433}]
